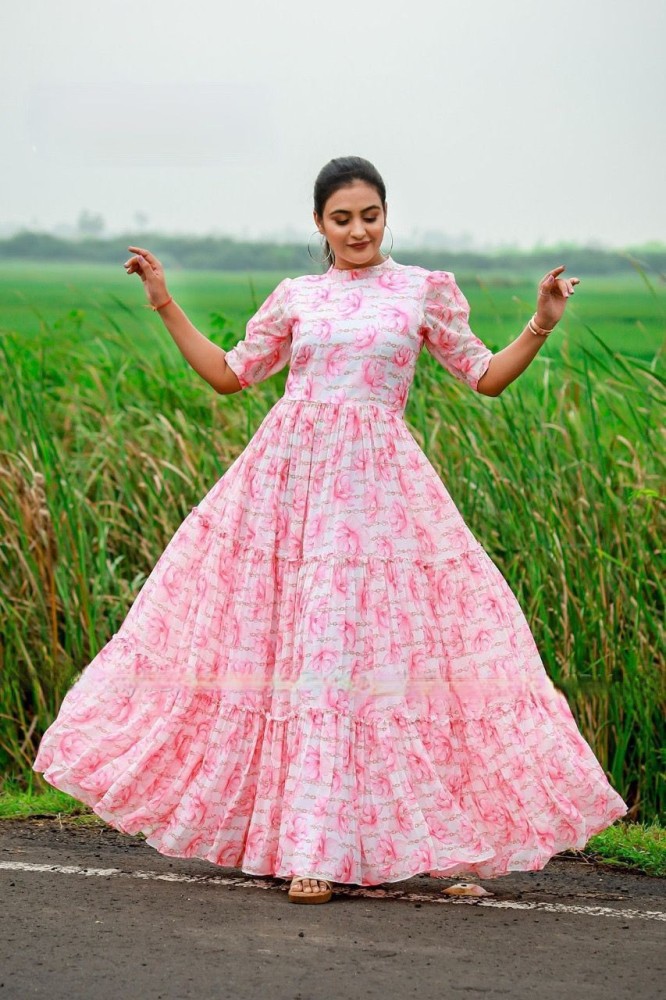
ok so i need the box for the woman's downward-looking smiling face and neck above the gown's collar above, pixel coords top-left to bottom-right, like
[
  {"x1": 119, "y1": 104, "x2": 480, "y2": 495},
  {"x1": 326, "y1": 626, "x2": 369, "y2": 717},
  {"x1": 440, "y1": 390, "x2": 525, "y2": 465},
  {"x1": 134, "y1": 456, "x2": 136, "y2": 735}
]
[{"x1": 313, "y1": 180, "x2": 386, "y2": 269}]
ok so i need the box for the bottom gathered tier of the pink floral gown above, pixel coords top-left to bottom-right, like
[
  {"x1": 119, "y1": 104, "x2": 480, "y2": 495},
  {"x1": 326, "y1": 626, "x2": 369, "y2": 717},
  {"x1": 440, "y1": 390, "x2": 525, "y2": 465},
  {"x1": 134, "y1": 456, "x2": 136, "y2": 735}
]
[{"x1": 33, "y1": 689, "x2": 627, "y2": 885}]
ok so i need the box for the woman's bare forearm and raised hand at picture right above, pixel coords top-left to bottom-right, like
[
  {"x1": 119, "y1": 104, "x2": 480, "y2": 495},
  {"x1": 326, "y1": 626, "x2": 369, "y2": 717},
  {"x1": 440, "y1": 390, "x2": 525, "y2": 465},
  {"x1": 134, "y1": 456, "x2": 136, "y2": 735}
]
[{"x1": 477, "y1": 264, "x2": 580, "y2": 396}]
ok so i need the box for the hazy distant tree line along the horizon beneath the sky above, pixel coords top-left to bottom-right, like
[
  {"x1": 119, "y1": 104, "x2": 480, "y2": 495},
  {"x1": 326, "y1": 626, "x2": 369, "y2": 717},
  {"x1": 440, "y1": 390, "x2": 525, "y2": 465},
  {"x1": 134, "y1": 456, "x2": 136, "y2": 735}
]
[{"x1": 0, "y1": 230, "x2": 666, "y2": 274}]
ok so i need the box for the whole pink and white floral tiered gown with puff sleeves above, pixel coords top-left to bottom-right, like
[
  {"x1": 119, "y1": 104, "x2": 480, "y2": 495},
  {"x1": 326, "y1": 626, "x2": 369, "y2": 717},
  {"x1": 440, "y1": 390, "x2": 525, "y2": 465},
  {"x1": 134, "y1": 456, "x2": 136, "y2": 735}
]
[{"x1": 33, "y1": 257, "x2": 627, "y2": 885}]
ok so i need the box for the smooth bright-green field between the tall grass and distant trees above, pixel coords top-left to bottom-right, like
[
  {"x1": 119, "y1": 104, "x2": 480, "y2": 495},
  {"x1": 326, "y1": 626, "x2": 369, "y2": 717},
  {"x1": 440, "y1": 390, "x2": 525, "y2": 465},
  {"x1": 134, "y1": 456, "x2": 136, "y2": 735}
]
[{"x1": 0, "y1": 261, "x2": 666, "y2": 366}]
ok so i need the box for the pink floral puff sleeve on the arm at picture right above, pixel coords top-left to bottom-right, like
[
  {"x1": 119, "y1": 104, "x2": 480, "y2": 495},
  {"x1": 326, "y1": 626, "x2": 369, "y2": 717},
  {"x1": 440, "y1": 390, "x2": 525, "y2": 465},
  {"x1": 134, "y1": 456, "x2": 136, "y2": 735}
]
[{"x1": 422, "y1": 271, "x2": 493, "y2": 390}]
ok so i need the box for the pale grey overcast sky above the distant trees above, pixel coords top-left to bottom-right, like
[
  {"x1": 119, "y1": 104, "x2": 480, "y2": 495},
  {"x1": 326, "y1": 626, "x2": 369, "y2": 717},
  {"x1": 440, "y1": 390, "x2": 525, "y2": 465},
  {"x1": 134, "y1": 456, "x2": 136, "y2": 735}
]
[{"x1": 0, "y1": 0, "x2": 666, "y2": 253}]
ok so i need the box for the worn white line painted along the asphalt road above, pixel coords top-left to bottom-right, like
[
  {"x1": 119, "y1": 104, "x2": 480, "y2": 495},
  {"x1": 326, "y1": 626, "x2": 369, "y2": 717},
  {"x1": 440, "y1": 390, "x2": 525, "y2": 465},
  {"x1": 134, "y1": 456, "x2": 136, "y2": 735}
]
[{"x1": 0, "y1": 861, "x2": 666, "y2": 920}]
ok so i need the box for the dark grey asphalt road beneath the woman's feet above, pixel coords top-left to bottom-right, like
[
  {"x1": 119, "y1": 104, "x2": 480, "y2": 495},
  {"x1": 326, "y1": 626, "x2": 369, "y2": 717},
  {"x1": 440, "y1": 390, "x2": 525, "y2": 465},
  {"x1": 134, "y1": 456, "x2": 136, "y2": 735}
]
[{"x1": 0, "y1": 818, "x2": 666, "y2": 1000}]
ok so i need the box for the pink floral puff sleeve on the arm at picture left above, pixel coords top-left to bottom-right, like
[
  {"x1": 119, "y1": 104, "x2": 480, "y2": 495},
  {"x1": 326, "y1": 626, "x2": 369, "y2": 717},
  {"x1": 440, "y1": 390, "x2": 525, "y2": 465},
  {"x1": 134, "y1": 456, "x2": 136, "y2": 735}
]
[{"x1": 225, "y1": 278, "x2": 292, "y2": 389}]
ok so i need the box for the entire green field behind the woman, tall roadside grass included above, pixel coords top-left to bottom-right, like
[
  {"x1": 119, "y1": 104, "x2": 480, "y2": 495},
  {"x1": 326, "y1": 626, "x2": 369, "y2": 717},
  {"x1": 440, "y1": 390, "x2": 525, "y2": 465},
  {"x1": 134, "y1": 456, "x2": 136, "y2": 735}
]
[{"x1": 0, "y1": 261, "x2": 666, "y2": 872}]
